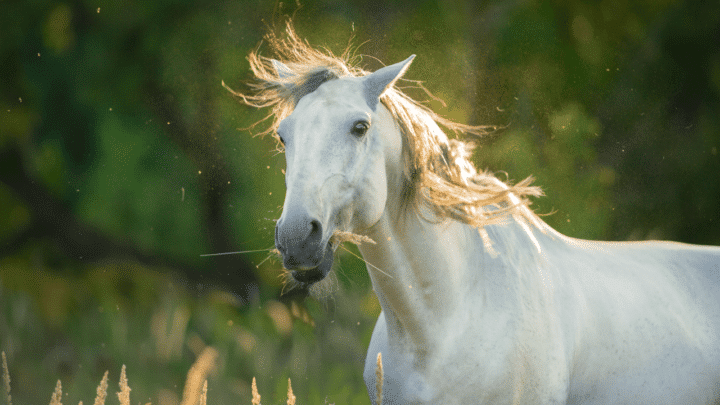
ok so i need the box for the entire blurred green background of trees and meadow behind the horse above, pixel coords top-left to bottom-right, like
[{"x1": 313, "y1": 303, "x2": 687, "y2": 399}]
[{"x1": 0, "y1": 0, "x2": 720, "y2": 405}]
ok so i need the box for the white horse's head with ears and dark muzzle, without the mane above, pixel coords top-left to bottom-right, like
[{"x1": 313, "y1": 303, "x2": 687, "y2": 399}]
[{"x1": 273, "y1": 56, "x2": 414, "y2": 285}]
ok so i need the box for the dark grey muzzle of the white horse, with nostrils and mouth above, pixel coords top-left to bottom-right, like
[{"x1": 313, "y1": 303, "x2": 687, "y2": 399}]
[{"x1": 275, "y1": 208, "x2": 334, "y2": 285}]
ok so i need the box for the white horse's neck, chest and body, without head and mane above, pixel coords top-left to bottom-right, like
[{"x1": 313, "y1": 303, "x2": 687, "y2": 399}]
[{"x1": 360, "y1": 201, "x2": 720, "y2": 404}]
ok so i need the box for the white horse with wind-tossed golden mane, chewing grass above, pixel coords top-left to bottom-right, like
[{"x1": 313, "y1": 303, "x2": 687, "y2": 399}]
[{"x1": 236, "y1": 26, "x2": 720, "y2": 404}]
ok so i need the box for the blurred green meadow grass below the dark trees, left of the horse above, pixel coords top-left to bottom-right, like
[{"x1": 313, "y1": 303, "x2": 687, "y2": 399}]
[{"x1": 0, "y1": 258, "x2": 379, "y2": 404}]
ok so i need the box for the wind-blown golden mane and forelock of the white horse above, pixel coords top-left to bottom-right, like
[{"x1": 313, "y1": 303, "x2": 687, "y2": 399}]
[{"x1": 233, "y1": 21, "x2": 542, "y2": 227}]
